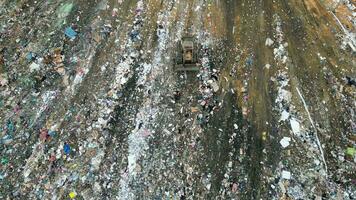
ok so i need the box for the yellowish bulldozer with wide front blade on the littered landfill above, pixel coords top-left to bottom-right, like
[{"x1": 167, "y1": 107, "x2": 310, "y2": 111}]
[{"x1": 175, "y1": 36, "x2": 199, "y2": 71}]
